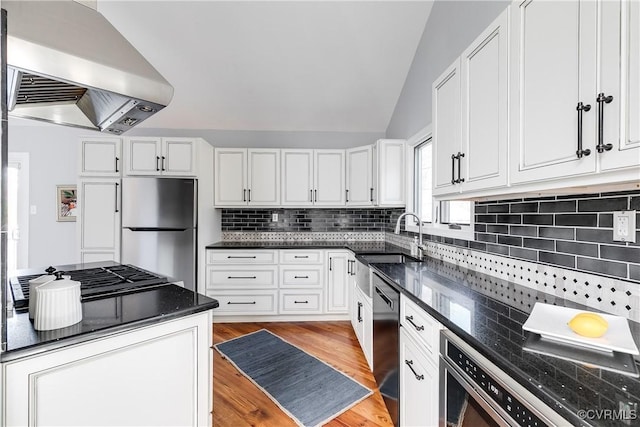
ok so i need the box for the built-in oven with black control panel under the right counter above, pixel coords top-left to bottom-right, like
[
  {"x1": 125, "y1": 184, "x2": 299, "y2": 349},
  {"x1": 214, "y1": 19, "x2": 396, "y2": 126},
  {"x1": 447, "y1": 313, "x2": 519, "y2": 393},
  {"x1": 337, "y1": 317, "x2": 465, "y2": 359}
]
[{"x1": 440, "y1": 331, "x2": 569, "y2": 427}]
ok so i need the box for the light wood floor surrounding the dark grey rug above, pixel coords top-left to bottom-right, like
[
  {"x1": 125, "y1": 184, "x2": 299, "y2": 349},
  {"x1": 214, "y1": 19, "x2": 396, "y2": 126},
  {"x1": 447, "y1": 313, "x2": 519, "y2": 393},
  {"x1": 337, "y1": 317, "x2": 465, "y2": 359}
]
[{"x1": 213, "y1": 322, "x2": 393, "y2": 427}]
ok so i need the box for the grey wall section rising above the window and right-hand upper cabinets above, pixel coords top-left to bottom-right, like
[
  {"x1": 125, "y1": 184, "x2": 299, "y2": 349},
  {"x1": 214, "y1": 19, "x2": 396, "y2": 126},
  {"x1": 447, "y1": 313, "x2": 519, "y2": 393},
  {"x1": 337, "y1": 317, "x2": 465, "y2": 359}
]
[{"x1": 386, "y1": 0, "x2": 510, "y2": 139}]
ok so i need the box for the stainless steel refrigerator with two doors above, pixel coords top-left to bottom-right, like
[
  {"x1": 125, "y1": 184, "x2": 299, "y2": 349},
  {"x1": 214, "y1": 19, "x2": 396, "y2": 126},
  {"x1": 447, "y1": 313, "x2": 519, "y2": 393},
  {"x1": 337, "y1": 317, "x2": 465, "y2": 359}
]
[{"x1": 121, "y1": 177, "x2": 198, "y2": 291}]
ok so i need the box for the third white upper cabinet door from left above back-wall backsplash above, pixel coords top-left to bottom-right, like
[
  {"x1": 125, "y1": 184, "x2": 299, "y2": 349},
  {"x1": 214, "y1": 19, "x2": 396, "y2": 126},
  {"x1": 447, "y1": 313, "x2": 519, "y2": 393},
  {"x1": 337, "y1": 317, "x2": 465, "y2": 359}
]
[{"x1": 281, "y1": 150, "x2": 313, "y2": 206}]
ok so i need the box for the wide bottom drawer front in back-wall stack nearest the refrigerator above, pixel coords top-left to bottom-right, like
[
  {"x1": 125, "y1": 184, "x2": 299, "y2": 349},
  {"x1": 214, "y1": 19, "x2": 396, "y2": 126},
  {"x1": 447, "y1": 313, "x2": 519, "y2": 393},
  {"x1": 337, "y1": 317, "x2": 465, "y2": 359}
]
[{"x1": 207, "y1": 291, "x2": 278, "y2": 317}]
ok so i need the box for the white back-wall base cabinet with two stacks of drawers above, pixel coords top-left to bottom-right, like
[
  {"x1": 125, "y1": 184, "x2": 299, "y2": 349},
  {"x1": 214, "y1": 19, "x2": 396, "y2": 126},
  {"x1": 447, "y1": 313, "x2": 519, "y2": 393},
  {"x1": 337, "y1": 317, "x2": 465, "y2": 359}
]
[{"x1": 206, "y1": 249, "x2": 351, "y2": 321}]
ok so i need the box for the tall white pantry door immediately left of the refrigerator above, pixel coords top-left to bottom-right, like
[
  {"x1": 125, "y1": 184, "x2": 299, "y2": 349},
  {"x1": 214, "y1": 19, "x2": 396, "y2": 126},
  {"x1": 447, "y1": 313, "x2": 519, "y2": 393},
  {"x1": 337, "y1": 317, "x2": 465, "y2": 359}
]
[{"x1": 78, "y1": 180, "x2": 120, "y2": 254}]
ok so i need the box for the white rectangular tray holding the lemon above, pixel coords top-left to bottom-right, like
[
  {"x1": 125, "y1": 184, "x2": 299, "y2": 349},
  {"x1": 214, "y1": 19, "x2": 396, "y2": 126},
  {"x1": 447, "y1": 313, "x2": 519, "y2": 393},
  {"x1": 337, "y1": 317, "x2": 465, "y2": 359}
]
[{"x1": 522, "y1": 302, "x2": 640, "y2": 355}]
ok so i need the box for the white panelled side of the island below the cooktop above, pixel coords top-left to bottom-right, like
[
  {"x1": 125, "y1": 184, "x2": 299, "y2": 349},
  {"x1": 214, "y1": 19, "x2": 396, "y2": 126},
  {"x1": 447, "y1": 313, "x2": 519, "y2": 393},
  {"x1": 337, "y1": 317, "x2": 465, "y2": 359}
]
[{"x1": 0, "y1": 311, "x2": 213, "y2": 426}]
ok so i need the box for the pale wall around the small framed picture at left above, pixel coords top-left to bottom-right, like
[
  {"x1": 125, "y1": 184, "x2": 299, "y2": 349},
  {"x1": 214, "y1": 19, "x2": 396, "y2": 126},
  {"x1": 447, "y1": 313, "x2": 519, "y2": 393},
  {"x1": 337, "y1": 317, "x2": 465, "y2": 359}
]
[{"x1": 8, "y1": 118, "x2": 101, "y2": 268}]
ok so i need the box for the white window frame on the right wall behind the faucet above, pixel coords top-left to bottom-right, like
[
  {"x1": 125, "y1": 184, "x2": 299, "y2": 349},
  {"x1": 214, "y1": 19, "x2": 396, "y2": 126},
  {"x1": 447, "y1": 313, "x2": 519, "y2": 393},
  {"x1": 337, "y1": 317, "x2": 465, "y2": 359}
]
[{"x1": 404, "y1": 125, "x2": 475, "y2": 241}]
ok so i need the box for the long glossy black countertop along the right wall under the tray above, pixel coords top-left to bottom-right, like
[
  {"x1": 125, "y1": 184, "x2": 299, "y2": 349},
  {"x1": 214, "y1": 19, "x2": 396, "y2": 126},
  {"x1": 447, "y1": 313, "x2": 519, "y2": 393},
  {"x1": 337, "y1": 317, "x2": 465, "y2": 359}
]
[{"x1": 374, "y1": 259, "x2": 640, "y2": 426}]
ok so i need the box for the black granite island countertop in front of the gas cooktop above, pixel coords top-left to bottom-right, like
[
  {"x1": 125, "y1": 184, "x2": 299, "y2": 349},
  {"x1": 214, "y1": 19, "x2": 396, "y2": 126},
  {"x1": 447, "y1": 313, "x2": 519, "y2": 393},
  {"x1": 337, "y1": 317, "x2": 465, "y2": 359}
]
[{"x1": 1, "y1": 284, "x2": 218, "y2": 361}]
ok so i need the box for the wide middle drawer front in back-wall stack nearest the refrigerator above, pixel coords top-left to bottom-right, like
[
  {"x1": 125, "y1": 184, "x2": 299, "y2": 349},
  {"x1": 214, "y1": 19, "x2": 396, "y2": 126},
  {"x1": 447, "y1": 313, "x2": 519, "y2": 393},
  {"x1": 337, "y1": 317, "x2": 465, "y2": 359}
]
[{"x1": 207, "y1": 265, "x2": 278, "y2": 289}]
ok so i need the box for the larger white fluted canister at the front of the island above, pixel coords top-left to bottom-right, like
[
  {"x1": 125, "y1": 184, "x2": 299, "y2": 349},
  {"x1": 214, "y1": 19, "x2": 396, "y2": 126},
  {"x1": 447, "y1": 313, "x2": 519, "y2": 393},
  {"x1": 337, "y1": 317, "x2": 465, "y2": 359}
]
[{"x1": 34, "y1": 279, "x2": 82, "y2": 331}]
